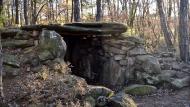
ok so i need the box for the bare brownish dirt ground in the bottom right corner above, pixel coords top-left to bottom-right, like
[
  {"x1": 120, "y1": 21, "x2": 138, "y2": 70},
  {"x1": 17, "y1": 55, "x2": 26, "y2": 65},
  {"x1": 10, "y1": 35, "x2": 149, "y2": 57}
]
[{"x1": 134, "y1": 87, "x2": 190, "y2": 107}]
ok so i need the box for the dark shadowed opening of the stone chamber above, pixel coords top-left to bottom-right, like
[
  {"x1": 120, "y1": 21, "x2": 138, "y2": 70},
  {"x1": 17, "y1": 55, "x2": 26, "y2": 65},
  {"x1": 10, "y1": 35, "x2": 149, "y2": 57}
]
[{"x1": 64, "y1": 36, "x2": 103, "y2": 84}]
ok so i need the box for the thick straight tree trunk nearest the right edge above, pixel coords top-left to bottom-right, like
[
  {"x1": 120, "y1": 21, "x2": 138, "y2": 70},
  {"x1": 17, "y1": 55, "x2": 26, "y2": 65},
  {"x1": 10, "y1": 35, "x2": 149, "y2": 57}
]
[{"x1": 179, "y1": 0, "x2": 189, "y2": 62}]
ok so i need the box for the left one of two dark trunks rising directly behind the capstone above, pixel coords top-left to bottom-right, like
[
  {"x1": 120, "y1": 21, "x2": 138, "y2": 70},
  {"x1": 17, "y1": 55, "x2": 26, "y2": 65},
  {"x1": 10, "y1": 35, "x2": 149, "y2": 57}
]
[{"x1": 74, "y1": 0, "x2": 81, "y2": 22}]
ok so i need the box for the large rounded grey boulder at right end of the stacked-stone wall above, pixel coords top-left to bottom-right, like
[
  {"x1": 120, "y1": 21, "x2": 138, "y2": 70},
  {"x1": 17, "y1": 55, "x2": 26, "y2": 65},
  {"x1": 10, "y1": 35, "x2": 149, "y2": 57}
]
[{"x1": 135, "y1": 55, "x2": 161, "y2": 74}]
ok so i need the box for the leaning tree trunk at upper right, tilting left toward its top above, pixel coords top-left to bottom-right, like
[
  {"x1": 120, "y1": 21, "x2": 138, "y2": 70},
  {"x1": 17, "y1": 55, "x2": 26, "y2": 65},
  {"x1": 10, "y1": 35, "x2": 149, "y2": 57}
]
[{"x1": 157, "y1": 0, "x2": 173, "y2": 49}]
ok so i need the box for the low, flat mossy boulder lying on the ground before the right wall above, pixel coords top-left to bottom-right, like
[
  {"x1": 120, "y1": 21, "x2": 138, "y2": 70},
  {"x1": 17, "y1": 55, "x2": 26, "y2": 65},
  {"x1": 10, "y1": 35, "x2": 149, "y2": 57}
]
[{"x1": 124, "y1": 84, "x2": 157, "y2": 95}]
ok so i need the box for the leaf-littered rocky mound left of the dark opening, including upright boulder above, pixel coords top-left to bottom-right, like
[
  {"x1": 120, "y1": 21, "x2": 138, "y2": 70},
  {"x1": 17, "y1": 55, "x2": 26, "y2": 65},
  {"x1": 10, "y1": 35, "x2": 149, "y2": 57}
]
[{"x1": 3, "y1": 30, "x2": 136, "y2": 107}]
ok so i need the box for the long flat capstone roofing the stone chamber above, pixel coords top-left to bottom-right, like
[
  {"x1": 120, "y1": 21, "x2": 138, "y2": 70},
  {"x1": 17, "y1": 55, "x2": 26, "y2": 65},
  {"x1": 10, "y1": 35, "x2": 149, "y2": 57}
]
[{"x1": 21, "y1": 23, "x2": 127, "y2": 36}]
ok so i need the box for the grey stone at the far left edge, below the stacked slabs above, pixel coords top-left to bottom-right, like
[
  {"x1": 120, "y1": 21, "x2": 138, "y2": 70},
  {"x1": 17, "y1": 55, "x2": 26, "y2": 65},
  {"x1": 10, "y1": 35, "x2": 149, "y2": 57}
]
[{"x1": 3, "y1": 54, "x2": 20, "y2": 68}]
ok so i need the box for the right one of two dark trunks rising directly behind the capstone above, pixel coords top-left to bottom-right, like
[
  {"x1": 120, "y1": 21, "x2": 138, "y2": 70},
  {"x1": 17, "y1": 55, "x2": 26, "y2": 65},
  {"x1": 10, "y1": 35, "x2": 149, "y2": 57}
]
[{"x1": 96, "y1": 0, "x2": 102, "y2": 21}]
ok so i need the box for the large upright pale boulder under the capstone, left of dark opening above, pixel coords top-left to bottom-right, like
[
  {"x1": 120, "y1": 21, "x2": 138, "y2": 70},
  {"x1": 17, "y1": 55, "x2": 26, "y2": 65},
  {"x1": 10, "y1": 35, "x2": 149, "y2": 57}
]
[{"x1": 38, "y1": 30, "x2": 67, "y2": 60}]
